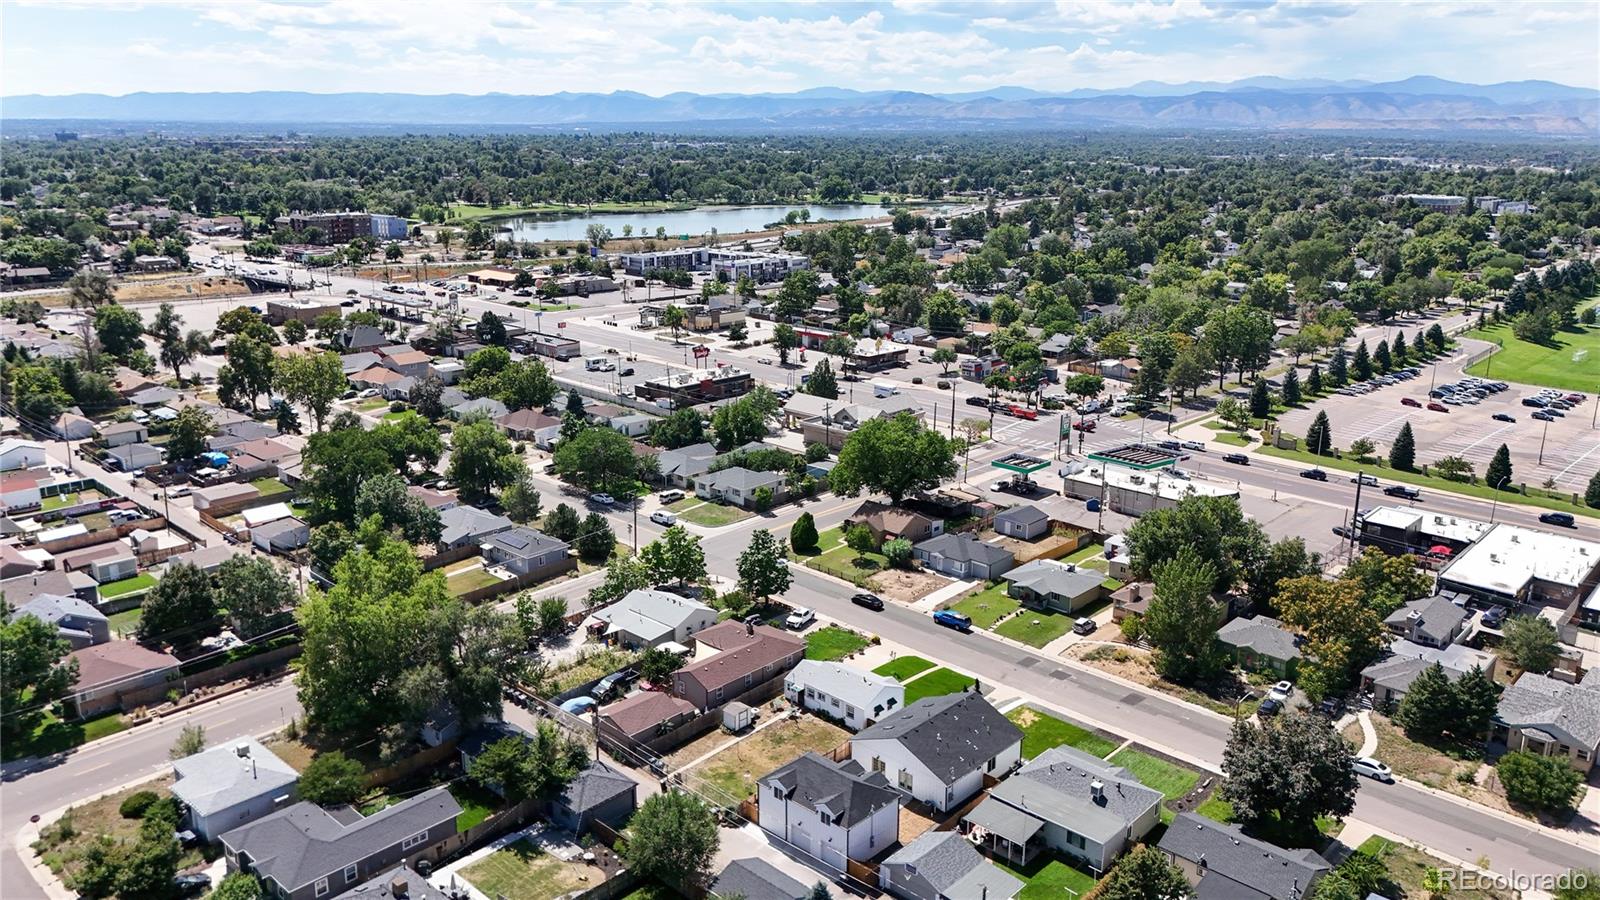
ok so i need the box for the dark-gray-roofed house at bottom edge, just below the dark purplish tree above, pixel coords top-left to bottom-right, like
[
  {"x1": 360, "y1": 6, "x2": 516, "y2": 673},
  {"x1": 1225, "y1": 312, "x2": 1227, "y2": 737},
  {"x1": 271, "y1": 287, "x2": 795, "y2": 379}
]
[{"x1": 1158, "y1": 812, "x2": 1333, "y2": 900}]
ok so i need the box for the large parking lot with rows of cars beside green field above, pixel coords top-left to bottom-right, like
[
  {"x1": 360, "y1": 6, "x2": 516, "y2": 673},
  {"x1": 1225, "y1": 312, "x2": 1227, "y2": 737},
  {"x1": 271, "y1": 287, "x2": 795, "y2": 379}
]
[{"x1": 1280, "y1": 370, "x2": 1600, "y2": 492}]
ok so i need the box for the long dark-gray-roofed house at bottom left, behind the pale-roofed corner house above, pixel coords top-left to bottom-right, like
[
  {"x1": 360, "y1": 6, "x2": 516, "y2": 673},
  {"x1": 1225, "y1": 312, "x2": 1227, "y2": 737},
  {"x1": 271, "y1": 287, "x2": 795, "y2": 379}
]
[{"x1": 221, "y1": 788, "x2": 461, "y2": 900}]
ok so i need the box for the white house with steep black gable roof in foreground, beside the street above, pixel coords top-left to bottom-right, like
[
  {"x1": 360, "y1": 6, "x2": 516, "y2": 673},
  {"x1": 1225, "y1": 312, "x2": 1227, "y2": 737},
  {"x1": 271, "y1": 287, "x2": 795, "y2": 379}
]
[{"x1": 850, "y1": 690, "x2": 1022, "y2": 812}]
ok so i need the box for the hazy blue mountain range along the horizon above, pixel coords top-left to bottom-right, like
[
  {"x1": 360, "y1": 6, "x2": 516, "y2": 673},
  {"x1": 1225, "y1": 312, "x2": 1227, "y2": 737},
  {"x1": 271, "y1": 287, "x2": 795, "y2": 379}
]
[{"x1": 0, "y1": 75, "x2": 1600, "y2": 138}]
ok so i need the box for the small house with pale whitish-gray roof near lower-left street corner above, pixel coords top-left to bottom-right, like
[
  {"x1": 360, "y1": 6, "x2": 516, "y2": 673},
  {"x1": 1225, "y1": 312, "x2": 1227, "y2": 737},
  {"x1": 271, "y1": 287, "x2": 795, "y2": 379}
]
[{"x1": 173, "y1": 737, "x2": 299, "y2": 842}]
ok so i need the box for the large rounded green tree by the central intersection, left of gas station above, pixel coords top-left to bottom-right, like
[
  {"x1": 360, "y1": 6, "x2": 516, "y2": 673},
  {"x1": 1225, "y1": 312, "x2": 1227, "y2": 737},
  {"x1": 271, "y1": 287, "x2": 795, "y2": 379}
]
[{"x1": 829, "y1": 413, "x2": 955, "y2": 504}]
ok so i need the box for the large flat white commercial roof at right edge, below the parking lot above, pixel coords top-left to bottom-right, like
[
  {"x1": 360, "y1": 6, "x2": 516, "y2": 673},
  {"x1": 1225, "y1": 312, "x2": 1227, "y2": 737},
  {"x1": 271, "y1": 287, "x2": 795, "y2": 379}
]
[{"x1": 1440, "y1": 524, "x2": 1600, "y2": 594}]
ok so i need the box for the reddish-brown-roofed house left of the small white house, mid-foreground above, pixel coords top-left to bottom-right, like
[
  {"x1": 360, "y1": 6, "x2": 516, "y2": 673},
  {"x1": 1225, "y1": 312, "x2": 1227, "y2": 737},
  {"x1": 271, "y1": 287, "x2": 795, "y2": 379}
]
[{"x1": 672, "y1": 620, "x2": 805, "y2": 711}]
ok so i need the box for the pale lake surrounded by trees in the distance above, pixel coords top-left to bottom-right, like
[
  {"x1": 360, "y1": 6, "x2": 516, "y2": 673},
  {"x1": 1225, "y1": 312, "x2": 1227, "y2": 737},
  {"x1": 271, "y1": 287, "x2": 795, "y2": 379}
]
[{"x1": 494, "y1": 203, "x2": 888, "y2": 240}]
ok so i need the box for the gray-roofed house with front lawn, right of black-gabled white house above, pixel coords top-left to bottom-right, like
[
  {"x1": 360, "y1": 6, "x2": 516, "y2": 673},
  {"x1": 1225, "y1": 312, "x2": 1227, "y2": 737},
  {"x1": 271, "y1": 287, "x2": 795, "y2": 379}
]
[{"x1": 963, "y1": 746, "x2": 1165, "y2": 871}]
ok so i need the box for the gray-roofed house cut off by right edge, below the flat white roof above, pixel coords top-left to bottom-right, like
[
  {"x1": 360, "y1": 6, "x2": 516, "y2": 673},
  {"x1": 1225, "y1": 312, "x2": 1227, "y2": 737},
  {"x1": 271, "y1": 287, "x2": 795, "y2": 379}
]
[{"x1": 1490, "y1": 669, "x2": 1600, "y2": 773}]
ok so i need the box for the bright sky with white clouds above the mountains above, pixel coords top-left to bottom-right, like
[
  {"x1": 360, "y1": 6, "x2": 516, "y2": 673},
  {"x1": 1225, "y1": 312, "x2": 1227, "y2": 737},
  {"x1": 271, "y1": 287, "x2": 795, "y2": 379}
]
[{"x1": 0, "y1": 0, "x2": 1600, "y2": 94}]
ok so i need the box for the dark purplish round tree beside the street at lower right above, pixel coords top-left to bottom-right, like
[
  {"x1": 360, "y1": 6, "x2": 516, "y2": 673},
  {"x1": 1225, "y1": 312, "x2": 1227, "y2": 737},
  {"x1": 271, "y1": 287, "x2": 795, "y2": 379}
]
[{"x1": 1219, "y1": 711, "x2": 1357, "y2": 834}]
